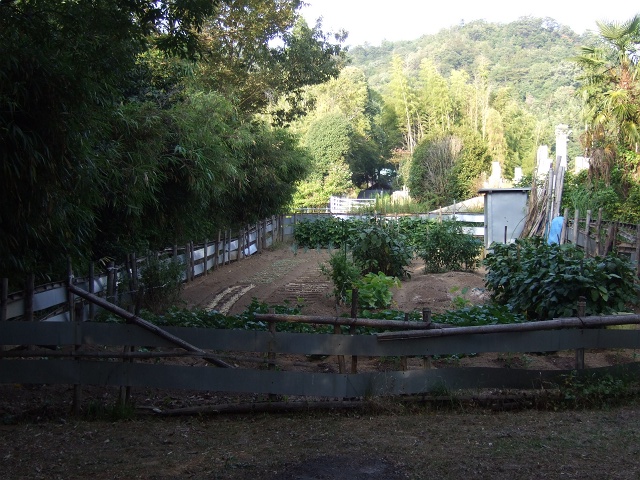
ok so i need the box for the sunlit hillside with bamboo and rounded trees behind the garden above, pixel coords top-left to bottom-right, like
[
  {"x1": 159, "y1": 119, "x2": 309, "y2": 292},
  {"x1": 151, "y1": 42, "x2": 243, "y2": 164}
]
[{"x1": 282, "y1": 18, "x2": 595, "y2": 208}]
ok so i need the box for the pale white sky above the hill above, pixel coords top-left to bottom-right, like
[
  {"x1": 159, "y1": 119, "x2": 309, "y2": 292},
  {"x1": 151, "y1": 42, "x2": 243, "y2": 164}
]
[{"x1": 301, "y1": 0, "x2": 640, "y2": 46}]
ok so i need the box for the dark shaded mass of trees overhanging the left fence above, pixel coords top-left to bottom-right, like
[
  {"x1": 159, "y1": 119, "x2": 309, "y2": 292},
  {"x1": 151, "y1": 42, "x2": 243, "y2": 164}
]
[{"x1": 0, "y1": 0, "x2": 344, "y2": 282}]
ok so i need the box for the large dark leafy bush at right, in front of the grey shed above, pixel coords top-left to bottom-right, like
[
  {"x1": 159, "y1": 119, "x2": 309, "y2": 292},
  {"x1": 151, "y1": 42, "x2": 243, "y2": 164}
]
[{"x1": 484, "y1": 238, "x2": 636, "y2": 320}]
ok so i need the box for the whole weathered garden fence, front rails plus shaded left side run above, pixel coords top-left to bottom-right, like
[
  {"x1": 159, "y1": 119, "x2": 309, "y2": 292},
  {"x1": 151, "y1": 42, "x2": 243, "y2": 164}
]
[{"x1": 0, "y1": 207, "x2": 640, "y2": 408}]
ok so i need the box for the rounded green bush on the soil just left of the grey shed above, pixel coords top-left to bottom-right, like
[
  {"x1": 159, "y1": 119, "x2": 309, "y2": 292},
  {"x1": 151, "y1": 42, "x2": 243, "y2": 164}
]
[{"x1": 417, "y1": 220, "x2": 482, "y2": 272}]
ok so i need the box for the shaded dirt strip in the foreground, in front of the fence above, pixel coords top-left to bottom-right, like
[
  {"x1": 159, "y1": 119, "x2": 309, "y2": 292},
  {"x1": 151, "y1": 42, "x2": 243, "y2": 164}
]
[{"x1": 0, "y1": 405, "x2": 640, "y2": 480}]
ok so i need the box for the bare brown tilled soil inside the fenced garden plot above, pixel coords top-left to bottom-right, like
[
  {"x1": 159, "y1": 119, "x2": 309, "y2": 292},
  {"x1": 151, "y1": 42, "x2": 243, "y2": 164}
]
[{"x1": 183, "y1": 245, "x2": 484, "y2": 315}]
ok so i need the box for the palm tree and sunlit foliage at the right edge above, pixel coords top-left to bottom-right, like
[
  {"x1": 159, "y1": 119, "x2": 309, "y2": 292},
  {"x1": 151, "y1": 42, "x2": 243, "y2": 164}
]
[{"x1": 563, "y1": 15, "x2": 640, "y2": 222}]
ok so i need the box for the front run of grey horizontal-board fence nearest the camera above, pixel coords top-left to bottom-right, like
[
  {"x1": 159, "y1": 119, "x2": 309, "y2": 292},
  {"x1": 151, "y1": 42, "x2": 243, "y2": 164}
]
[{"x1": 0, "y1": 308, "x2": 640, "y2": 398}]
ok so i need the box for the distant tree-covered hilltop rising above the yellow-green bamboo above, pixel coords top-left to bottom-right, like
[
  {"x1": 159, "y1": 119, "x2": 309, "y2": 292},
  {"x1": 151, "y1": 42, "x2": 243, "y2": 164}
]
[{"x1": 349, "y1": 17, "x2": 595, "y2": 167}]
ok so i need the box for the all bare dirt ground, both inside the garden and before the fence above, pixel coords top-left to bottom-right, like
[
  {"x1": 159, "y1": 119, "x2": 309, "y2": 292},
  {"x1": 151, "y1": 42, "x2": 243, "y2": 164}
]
[{"x1": 0, "y1": 246, "x2": 640, "y2": 480}]
